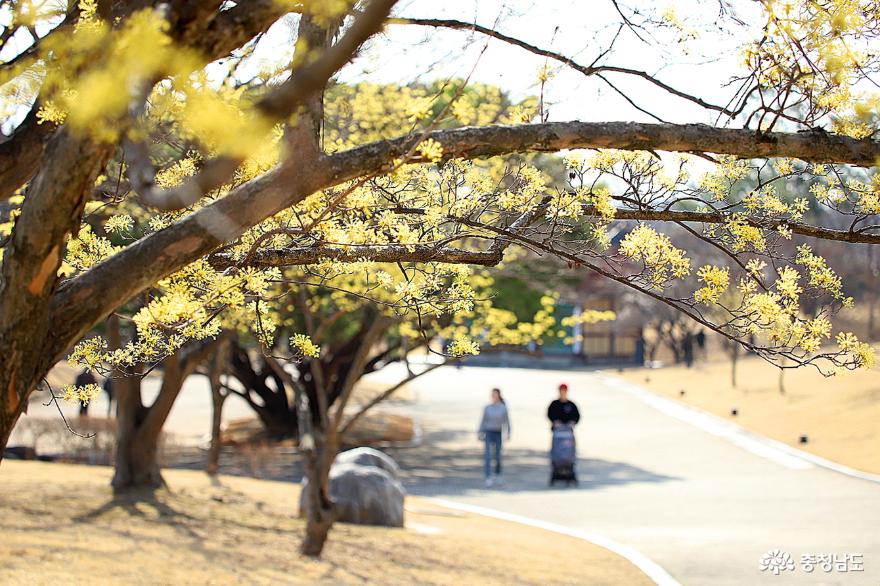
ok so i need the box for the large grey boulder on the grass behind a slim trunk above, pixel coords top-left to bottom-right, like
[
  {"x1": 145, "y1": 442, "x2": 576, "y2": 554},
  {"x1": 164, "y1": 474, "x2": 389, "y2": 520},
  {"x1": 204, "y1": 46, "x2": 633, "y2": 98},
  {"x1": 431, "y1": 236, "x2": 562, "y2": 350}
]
[{"x1": 299, "y1": 450, "x2": 406, "y2": 527}]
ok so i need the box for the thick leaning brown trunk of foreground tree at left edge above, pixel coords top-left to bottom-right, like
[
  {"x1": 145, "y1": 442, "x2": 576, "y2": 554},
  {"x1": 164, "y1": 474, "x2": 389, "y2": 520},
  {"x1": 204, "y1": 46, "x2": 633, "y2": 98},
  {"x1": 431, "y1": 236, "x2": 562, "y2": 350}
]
[{"x1": 0, "y1": 131, "x2": 112, "y2": 460}]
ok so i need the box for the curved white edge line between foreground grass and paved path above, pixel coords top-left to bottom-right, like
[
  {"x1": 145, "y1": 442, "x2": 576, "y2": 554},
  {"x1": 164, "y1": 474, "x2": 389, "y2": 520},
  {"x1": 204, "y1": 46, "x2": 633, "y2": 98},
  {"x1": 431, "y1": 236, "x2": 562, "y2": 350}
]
[{"x1": 422, "y1": 498, "x2": 681, "y2": 586}]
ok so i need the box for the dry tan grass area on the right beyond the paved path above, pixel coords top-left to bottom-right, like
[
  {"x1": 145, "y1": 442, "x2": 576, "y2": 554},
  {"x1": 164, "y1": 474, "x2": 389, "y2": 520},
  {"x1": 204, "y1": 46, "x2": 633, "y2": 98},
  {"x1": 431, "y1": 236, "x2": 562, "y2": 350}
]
[{"x1": 618, "y1": 356, "x2": 880, "y2": 473}]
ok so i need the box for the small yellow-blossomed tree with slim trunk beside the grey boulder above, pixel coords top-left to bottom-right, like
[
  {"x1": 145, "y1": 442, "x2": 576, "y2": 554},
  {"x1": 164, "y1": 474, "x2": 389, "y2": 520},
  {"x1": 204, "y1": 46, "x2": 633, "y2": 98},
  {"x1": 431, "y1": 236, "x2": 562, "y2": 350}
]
[{"x1": 230, "y1": 264, "x2": 572, "y2": 555}]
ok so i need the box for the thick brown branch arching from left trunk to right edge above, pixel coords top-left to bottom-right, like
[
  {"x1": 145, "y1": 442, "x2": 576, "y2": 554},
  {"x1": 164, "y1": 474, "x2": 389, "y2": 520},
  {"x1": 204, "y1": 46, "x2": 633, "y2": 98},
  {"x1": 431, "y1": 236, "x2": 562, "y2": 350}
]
[{"x1": 52, "y1": 122, "x2": 880, "y2": 364}]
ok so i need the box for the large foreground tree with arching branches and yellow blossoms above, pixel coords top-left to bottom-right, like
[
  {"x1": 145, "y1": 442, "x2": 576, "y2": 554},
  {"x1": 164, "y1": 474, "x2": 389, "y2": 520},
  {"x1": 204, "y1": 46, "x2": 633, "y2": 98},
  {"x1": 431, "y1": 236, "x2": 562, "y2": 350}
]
[{"x1": 0, "y1": 0, "x2": 880, "y2": 548}]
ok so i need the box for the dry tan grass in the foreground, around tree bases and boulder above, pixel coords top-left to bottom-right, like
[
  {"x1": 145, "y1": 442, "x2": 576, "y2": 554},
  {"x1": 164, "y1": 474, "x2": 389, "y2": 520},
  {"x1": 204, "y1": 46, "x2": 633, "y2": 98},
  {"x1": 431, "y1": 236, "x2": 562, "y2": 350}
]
[{"x1": 0, "y1": 461, "x2": 650, "y2": 586}]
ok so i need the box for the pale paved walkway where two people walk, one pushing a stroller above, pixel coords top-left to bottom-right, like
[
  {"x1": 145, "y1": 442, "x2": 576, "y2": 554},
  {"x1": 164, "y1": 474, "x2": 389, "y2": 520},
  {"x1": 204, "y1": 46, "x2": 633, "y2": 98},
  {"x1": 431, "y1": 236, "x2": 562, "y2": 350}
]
[{"x1": 370, "y1": 367, "x2": 880, "y2": 585}]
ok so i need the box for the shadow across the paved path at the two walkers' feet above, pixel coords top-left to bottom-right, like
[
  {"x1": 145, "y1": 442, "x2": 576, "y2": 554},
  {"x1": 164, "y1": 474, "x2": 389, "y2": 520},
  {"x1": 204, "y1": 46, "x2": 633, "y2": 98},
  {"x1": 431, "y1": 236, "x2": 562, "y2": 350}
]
[{"x1": 388, "y1": 430, "x2": 679, "y2": 496}]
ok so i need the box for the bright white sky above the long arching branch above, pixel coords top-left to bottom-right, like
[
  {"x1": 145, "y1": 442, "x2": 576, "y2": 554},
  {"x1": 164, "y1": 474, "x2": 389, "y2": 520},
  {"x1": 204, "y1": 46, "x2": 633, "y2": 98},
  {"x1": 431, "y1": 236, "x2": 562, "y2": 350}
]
[{"x1": 244, "y1": 0, "x2": 768, "y2": 128}]
